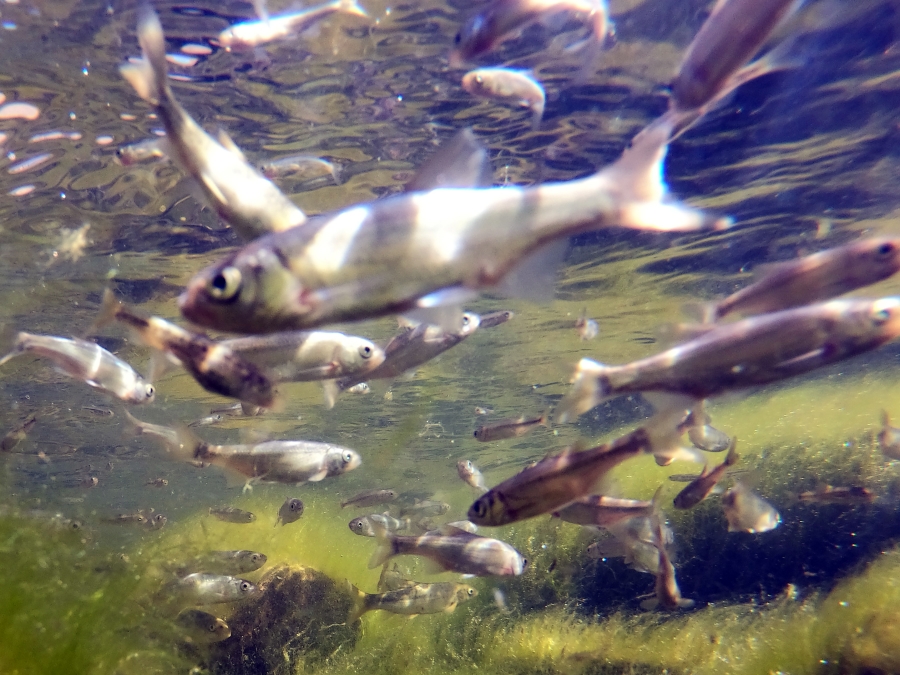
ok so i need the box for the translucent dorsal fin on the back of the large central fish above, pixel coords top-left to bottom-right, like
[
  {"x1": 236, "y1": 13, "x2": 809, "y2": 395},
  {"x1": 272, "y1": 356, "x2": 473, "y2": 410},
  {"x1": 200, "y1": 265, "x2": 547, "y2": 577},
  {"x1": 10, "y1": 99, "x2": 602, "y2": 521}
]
[{"x1": 405, "y1": 127, "x2": 493, "y2": 192}]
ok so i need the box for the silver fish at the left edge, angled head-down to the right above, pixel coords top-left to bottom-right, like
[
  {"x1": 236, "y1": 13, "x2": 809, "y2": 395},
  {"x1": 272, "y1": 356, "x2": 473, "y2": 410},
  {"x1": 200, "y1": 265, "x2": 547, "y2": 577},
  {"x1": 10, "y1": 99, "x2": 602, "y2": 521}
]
[{"x1": 0, "y1": 332, "x2": 156, "y2": 405}]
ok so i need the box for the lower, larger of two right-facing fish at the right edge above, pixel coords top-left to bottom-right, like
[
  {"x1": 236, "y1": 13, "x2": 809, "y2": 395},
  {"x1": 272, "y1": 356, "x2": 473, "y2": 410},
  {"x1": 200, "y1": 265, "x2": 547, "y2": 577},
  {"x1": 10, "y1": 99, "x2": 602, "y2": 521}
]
[{"x1": 556, "y1": 297, "x2": 900, "y2": 422}]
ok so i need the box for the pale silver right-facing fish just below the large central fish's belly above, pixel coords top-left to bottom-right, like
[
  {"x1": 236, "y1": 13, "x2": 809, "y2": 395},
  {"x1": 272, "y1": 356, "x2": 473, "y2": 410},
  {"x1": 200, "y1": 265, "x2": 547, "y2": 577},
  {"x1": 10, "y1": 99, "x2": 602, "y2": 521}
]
[{"x1": 220, "y1": 331, "x2": 385, "y2": 382}]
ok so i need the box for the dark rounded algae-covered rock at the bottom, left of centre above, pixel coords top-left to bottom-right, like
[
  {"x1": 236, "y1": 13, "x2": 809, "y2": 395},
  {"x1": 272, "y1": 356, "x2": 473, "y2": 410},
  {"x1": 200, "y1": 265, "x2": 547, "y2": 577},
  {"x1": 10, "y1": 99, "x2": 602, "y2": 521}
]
[{"x1": 210, "y1": 565, "x2": 359, "y2": 675}]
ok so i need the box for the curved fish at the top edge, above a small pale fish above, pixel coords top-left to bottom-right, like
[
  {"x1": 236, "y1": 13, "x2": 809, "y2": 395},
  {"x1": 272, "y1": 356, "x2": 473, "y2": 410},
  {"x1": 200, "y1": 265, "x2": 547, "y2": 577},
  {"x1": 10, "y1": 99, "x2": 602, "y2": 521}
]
[{"x1": 450, "y1": 0, "x2": 615, "y2": 68}]
